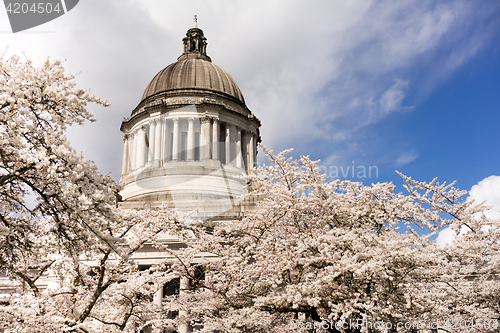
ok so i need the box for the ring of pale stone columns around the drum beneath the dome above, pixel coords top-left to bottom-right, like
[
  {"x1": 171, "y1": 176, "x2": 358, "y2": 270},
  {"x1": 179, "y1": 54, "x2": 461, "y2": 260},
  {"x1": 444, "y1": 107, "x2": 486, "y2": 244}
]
[{"x1": 122, "y1": 116, "x2": 257, "y2": 175}]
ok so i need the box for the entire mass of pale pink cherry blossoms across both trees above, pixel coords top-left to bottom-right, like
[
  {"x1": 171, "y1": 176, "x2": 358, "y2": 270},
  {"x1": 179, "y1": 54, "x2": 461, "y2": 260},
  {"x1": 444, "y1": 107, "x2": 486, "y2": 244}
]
[{"x1": 0, "y1": 56, "x2": 500, "y2": 332}]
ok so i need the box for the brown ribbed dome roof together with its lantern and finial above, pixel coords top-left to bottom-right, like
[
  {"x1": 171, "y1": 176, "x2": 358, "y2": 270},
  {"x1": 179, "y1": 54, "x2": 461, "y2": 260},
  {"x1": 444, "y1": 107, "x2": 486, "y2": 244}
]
[{"x1": 141, "y1": 24, "x2": 245, "y2": 105}]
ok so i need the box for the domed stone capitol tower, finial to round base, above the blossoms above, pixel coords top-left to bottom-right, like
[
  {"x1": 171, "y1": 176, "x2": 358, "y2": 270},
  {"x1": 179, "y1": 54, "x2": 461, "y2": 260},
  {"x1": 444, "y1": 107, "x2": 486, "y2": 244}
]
[{"x1": 120, "y1": 17, "x2": 261, "y2": 221}]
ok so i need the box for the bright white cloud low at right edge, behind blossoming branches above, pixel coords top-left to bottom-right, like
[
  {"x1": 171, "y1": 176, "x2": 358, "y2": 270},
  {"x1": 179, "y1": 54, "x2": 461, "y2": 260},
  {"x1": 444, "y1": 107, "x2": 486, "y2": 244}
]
[{"x1": 436, "y1": 176, "x2": 500, "y2": 246}]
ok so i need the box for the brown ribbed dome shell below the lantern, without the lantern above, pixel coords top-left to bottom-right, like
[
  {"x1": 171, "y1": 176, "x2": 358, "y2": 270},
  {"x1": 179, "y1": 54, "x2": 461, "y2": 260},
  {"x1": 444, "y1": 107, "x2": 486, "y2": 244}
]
[{"x1": 142, "y1": 58, "x2": 245, "y2": 104}]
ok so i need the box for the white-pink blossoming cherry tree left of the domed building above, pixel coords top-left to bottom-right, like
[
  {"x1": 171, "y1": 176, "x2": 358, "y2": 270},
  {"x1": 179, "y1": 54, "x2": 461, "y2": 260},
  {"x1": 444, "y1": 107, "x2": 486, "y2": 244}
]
[{"x1": 0, "y1": 56, "x2": 179, "y2": 332}]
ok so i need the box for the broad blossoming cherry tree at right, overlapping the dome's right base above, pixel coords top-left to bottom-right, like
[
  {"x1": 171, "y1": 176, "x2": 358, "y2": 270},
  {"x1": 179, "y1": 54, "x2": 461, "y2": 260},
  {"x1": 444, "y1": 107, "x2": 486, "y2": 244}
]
[{"x1": 155, "y1": 148, "x2": 499, "y2": 332}]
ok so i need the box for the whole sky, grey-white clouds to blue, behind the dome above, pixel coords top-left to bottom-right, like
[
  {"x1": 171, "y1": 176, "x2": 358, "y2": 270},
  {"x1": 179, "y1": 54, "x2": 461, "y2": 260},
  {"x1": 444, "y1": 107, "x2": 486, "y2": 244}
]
[{"x1": 0, "y1": 0, "x2": 500, "y2": 231}]
